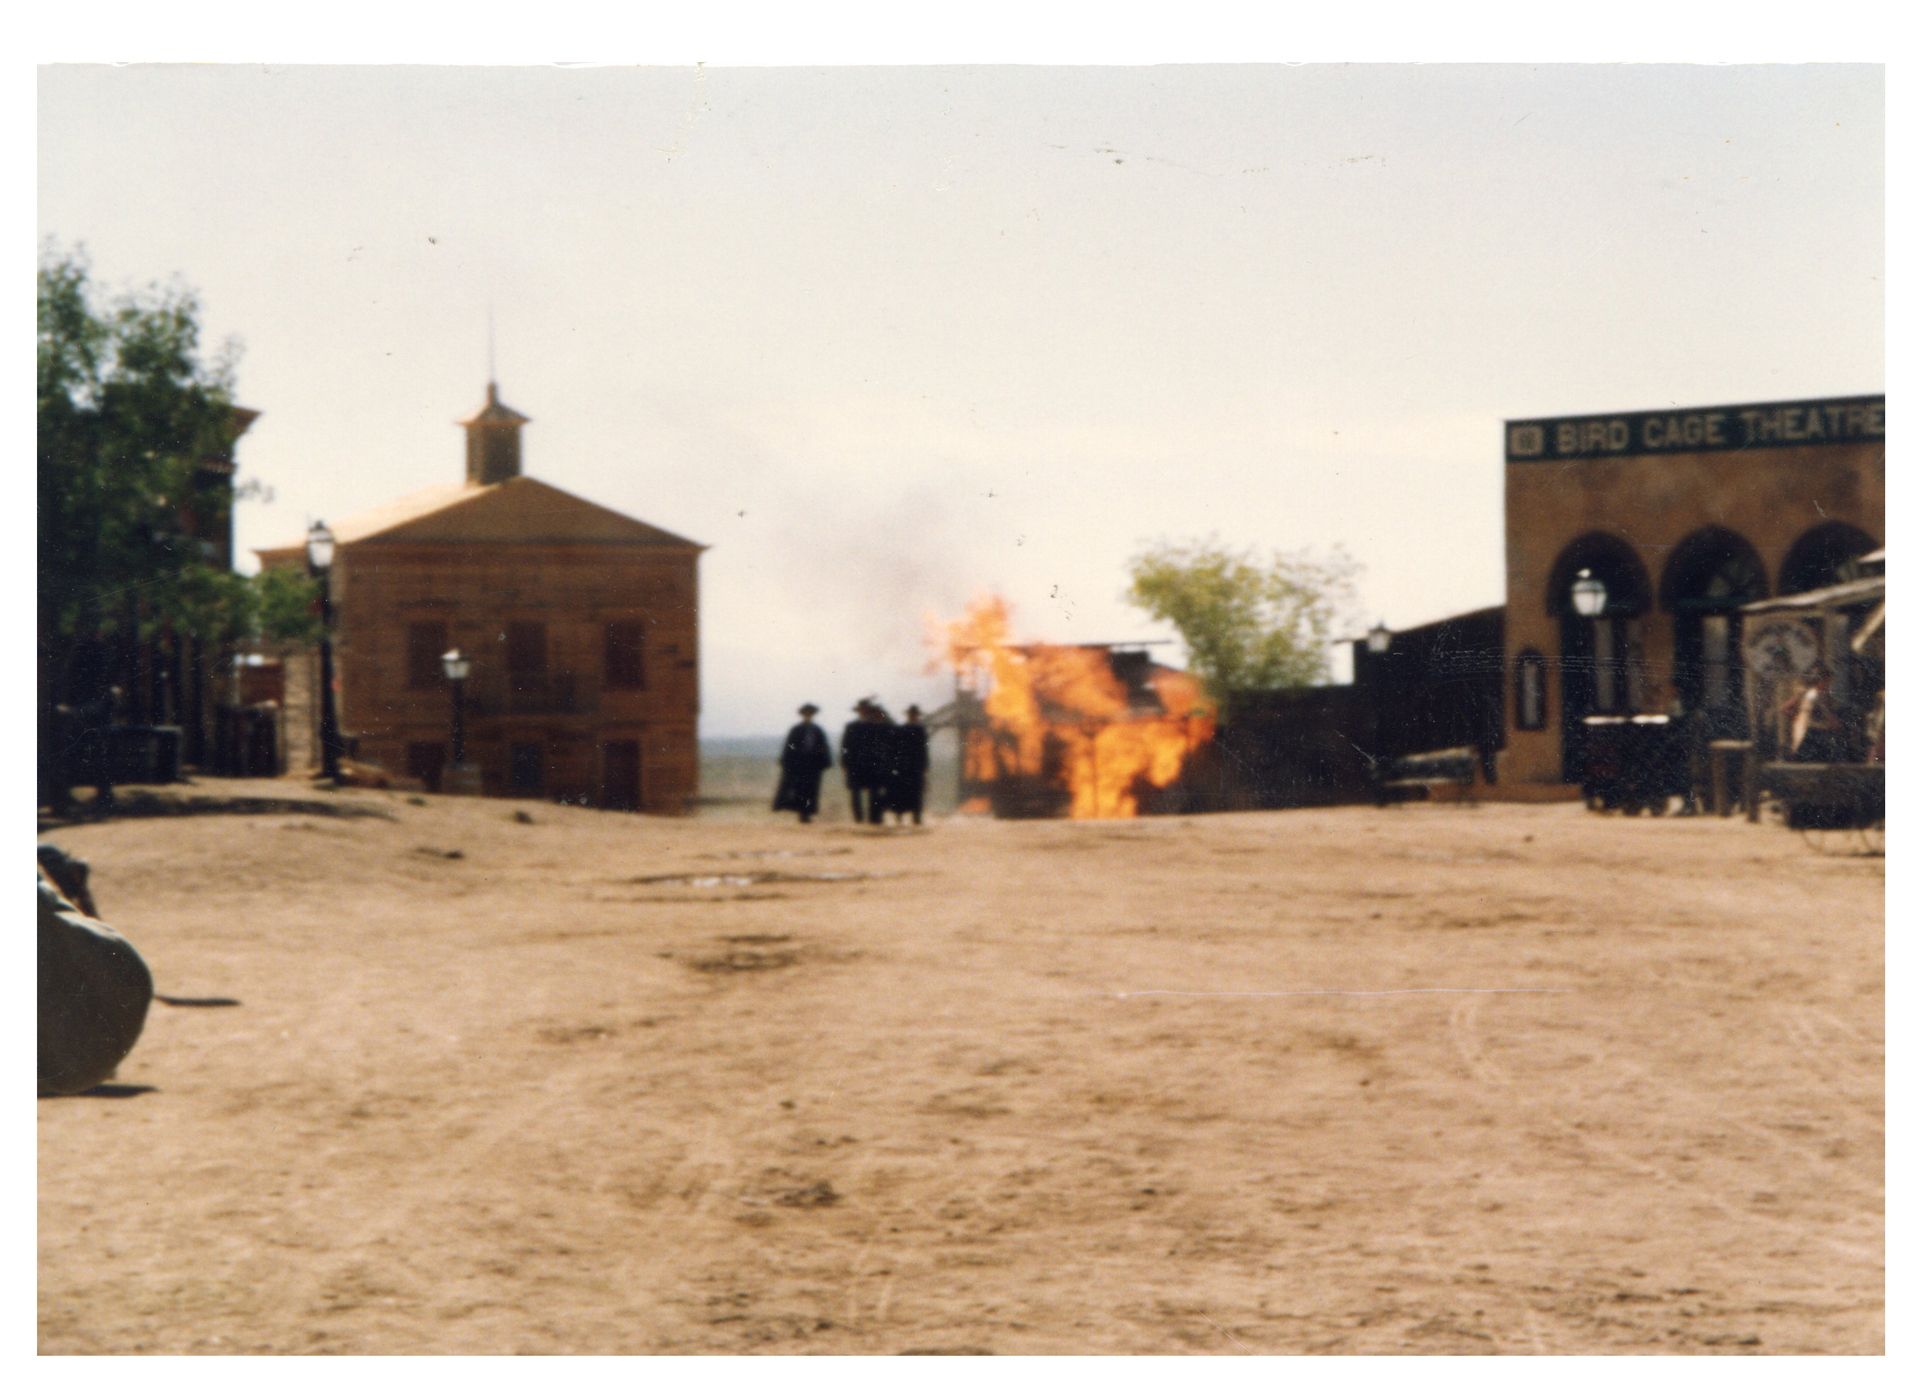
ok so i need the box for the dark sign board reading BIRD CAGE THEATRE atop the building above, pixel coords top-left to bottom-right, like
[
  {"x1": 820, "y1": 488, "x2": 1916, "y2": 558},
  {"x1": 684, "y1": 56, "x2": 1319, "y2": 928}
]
[{"x1": 1507, "y1": 395, "x2": 1887, "y2": 462}]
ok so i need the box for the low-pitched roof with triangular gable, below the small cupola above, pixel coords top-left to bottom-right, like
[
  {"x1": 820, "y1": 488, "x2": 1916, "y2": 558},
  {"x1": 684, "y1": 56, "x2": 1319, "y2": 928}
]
[{"x1": 255, "y1": 476, "x2": 705, "y2": 560}]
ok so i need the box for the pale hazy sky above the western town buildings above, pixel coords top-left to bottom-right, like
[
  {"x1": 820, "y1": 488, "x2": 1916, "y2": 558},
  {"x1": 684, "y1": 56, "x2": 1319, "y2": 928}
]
[{"x1": 38, "y1": 65, "x2": 1885, "y2": 735}]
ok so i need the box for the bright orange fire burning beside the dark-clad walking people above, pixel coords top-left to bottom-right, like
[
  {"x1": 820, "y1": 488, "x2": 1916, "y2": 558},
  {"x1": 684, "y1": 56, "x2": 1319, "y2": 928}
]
[{"x1": 943, "y1": 597, "x2": 1213, "y2": 819}]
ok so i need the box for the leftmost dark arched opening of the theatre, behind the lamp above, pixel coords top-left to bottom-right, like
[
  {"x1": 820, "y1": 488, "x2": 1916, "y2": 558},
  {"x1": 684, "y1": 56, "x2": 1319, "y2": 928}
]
[{"x1": 1546, "y1": 533, "x2": 1653, "y2": 781}]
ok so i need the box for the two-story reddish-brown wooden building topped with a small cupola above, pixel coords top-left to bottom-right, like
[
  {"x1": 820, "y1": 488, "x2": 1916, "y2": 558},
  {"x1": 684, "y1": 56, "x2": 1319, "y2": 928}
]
[{"x1": 259, "y1": 384, "x2": 705, "y2": 814}]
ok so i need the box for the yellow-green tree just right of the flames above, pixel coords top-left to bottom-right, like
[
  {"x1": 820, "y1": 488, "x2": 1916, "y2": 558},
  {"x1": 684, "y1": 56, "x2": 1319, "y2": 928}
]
[{"x1": 1127, "y1": 537, "x2": 1359, "y2": 704}]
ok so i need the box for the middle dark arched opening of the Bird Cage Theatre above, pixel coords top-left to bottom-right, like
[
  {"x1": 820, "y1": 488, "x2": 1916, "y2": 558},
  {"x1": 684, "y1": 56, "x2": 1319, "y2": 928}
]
[{"x1": 1661, "y1": 528, "x2": 1766, "y2": 737}]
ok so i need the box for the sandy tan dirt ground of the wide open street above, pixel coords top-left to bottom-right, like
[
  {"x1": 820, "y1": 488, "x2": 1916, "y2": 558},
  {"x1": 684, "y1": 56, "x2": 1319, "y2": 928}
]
[{"x1": 38, "y1": 781, "x2": 1884, "y2": 1353}]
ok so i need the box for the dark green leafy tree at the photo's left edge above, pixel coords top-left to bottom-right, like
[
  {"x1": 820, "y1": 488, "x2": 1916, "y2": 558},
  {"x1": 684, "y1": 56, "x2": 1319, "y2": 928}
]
[{"x1": 35, "y1": 242, "x2": 288, "y2": 794}]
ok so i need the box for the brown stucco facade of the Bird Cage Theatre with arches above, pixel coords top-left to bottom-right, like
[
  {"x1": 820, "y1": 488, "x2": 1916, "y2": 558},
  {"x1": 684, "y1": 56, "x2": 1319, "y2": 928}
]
[{"x1": 1498, "y1": 395, "x2": 1885, "y2": 785}]
